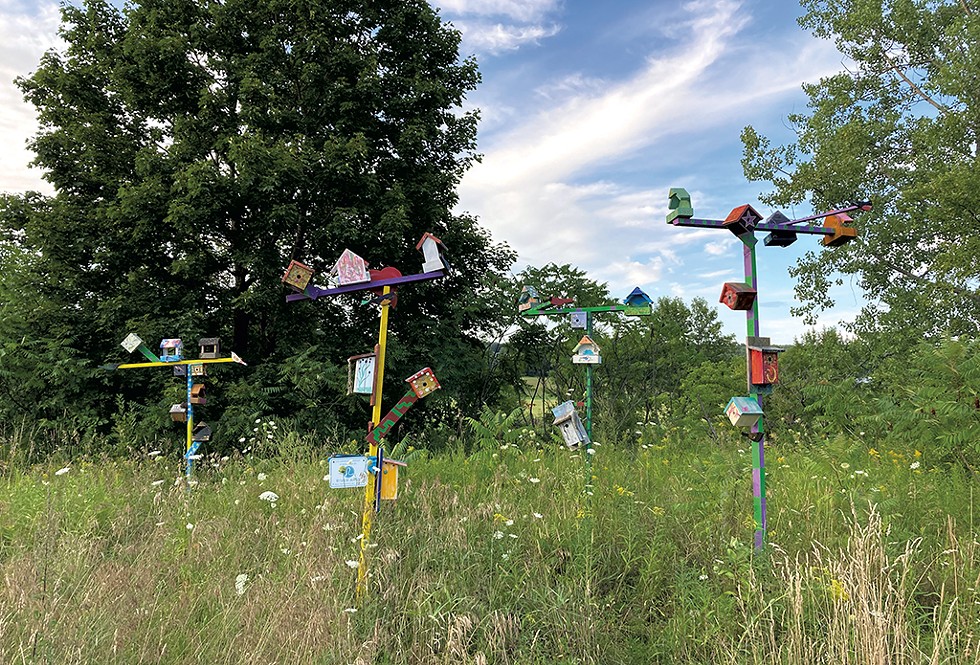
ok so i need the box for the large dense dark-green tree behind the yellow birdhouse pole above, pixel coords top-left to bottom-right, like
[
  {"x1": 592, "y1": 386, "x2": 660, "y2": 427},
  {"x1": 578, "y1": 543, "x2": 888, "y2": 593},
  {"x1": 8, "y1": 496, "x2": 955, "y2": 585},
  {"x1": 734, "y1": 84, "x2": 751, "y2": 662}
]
[{"x1": 0, "y1": 0, "x2": 512, "y2": 446}]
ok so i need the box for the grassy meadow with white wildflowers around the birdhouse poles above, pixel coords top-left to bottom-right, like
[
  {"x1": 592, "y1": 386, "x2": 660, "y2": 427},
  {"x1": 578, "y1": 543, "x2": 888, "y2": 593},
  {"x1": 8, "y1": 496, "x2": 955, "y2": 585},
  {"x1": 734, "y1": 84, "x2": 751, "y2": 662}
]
[{"x1": 0, "y1": 422, "x2": 980, "y2": 664}]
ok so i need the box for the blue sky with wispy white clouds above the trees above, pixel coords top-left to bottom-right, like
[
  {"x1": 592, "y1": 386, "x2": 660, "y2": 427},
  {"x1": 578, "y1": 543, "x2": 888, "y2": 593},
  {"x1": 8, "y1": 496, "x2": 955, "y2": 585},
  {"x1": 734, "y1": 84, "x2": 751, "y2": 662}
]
[{"x1": 0, "y1": 0, "x2": 862, "y2": 343}]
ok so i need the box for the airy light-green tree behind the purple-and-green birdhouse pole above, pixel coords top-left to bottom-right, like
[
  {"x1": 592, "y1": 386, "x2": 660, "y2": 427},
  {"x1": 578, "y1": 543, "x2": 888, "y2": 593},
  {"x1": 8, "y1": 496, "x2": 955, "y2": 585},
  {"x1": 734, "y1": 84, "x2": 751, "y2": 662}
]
[{"x1": 742, "y1": 0, "x2": 980, "y2": 339}]
